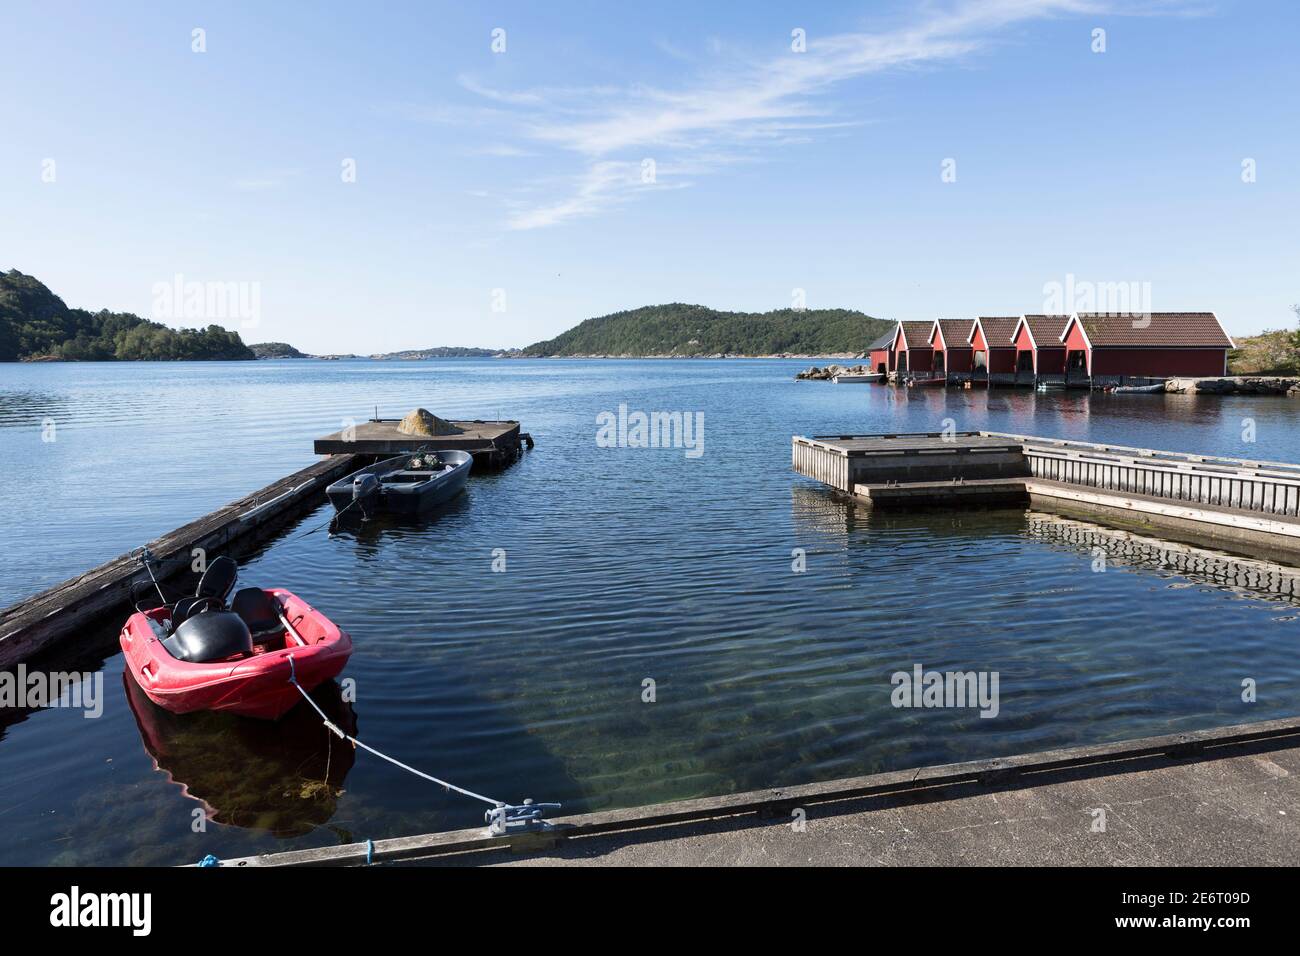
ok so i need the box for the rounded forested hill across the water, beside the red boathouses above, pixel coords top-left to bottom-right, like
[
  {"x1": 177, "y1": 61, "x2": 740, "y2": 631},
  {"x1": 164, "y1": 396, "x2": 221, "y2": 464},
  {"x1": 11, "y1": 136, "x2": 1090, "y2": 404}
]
[{"x1": 523, "y1": 302, "x2": 892, "y2": 356}]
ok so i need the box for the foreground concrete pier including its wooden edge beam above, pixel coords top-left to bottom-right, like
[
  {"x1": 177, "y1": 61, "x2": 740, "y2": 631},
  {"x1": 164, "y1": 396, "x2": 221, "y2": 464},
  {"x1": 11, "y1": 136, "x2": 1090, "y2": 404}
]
[{"x1": 222, "y1": 718, "x2": 1300, "y2": 868}]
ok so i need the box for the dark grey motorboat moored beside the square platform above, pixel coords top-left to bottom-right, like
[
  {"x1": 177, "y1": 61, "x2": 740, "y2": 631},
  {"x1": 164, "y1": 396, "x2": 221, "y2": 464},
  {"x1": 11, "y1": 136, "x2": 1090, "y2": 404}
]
[{"x1": 325, "y1": 451, "x2": 475, "y2": 518}]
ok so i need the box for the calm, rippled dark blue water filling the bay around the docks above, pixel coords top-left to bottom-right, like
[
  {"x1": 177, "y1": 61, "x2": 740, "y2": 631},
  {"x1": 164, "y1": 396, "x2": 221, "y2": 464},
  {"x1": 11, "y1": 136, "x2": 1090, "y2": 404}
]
[{"x1": 0, "y1": 360, "x2": 1300, "y2": 864}]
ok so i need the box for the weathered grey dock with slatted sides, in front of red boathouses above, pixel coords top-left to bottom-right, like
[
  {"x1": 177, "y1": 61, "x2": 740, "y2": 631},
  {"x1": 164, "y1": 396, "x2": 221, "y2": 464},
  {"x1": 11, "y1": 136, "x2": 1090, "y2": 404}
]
[{"x1": 793, "y1": 432, "x2": 1300, "y2": 559}]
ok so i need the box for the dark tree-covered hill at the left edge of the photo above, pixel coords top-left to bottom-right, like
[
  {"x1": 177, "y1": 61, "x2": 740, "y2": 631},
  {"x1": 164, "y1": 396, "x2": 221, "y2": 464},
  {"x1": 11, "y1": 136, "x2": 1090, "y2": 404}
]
[{"x1": 0, "y1": 269, "x2": 256, "y2": 362}]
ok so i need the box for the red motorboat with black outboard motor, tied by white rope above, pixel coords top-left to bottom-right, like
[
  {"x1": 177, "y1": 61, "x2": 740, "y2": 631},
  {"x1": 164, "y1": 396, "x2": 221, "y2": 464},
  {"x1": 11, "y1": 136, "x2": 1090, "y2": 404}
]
[{"x1": 118, "y1": 557, "x2": 352, "y2": 721}]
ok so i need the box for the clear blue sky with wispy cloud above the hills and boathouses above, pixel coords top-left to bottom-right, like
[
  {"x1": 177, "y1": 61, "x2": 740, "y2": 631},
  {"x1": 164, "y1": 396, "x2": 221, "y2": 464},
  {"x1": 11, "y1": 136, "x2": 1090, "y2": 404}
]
[{"x1": 0, "y1": 0, "x2": 1300, "y2": 352}]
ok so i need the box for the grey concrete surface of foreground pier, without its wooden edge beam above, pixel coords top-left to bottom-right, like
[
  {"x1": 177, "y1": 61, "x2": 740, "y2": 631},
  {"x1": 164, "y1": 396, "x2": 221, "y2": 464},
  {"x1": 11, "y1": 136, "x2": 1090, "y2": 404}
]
[{"x1": 491, "y1": 748, "x2": 1300, "y2": 866}]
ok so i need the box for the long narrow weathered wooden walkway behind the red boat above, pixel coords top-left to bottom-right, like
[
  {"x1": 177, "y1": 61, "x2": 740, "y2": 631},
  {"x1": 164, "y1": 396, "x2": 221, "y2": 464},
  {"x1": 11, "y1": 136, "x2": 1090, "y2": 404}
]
[{"x1": 0, "y1": 455, "x2": 368, "y2": 667}]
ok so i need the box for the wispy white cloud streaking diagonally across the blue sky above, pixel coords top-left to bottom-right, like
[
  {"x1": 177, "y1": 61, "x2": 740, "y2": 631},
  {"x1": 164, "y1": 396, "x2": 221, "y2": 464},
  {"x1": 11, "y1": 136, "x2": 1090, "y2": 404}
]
[{"x1": 441, "y1": 0, "x2": 1179, "y2": 229}]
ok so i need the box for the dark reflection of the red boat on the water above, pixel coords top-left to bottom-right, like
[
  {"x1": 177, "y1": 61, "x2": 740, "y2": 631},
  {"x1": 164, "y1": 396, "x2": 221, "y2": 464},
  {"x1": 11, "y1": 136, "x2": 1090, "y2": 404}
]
[{"x1": 122, "y1": 671, "x2": 356, "y2": 838}]
